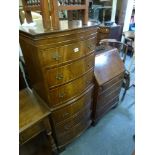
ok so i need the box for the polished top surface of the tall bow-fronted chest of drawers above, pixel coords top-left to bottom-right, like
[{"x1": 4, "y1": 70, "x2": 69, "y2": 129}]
[{"x1": 19, "y1": 20, "x2": 99, "y2": 37}]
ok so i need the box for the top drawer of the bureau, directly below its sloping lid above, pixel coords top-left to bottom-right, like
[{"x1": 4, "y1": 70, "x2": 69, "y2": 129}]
[{"x1": 99, "y1": 73, "x2": 124, "y2": 94}]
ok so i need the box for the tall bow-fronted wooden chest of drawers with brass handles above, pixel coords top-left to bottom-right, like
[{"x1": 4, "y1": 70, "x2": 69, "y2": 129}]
[{"x1": 20, "y1": 21, "x2": 97, "y2": 149}]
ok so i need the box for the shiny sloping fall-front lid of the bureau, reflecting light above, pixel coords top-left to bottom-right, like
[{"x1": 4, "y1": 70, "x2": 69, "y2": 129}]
[{"x1": 94, "y1": 49, "x2": 125, "y2": 86}]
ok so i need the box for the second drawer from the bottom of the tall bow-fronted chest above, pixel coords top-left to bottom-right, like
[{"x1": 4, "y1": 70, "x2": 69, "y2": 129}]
[{"x1": 55, "y1": 108, "x2": 91, "y2": 136}]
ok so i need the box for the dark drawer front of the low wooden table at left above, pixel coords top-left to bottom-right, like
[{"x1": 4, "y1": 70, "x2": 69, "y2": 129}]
[{"x1": 19, "y1": 122, "x2": 45, "y2": 144}]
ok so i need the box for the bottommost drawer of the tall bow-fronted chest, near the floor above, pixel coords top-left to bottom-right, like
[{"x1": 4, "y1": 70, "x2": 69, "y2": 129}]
[{"x1": 57, "y1": 119, "x2": 91, "y2": 146}]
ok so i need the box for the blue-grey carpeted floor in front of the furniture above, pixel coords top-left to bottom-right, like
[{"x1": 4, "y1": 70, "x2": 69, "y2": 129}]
[{"x1": 60, "y1": 56, "x2": 135, "y2": 155}]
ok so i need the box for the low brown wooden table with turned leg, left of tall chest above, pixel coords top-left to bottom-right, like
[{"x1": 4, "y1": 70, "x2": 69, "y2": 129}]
[{"x1": 19, "y1": 88, "x2": 57, "y2": 154}]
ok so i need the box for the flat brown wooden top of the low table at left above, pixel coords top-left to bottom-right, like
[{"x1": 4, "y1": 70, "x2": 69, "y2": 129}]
[{"x1": 19, "y1": 89, "x2": 50, "y2": 132}]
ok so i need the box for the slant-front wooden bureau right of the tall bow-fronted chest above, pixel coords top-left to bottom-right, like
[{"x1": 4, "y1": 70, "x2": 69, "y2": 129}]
[{"x1": 93, "y1": 49, "x2": 125, "y2": 124}]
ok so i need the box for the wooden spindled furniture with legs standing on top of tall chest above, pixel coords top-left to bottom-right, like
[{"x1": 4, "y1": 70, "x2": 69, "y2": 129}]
[{"x1": 22, "y1": 0, "x2": 89, "y2": 30}]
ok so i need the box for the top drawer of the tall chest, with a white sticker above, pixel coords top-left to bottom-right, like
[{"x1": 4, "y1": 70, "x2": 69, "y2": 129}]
[{"x1": 39, "y1": 37, "x2": 96, "y2": 66}]
